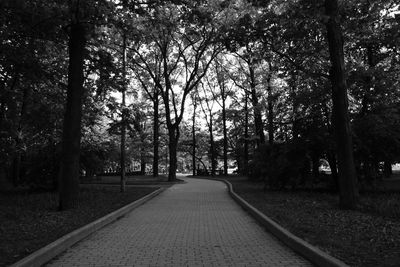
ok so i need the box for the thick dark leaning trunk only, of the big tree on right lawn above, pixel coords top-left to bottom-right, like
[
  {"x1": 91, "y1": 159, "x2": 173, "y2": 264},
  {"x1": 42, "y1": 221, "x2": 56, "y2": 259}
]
[{"x1": 325, "y1": 0, "x2": 358, "y2": 209}]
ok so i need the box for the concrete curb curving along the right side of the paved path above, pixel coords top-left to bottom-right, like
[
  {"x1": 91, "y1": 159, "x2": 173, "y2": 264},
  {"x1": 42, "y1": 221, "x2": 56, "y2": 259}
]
[{"x1": 202, "y1": 178, "x2": 348, "y2": 267}]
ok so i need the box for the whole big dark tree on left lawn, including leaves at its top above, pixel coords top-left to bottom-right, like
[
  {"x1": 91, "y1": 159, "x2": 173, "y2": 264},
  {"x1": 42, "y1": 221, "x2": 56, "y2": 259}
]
[{"x1": 59, "y1": 1, "x2": 115, "y2": 210}]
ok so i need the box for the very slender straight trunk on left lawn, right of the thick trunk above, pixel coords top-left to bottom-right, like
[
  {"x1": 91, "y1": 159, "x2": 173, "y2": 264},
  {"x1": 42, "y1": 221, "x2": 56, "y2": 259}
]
[{"x1": 120, "y1": 32, "x2": 126, "y2": 192}]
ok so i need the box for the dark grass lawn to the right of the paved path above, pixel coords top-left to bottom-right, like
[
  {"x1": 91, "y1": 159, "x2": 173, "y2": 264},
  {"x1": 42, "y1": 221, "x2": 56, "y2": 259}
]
[{"x1": 227, "y1": 177, "x2": 400, "y2": 267}]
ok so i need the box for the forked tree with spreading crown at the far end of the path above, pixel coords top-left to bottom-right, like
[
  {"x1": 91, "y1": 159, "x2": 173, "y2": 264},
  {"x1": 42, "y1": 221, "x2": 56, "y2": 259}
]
[{"x1": 130, "y1": 3, "x2": 219, "y2": 181}]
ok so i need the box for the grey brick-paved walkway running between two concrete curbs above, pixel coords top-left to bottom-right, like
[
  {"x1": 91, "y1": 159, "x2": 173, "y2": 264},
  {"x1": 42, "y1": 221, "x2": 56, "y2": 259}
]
[{"x1": 49, "y1": 178, "x2": 311, "y2": 267}]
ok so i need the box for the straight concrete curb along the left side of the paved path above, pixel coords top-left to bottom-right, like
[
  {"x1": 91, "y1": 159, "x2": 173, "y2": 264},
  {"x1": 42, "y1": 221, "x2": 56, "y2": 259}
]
[{"x1": 10, "y1": 188, "x2": 165, "y2": 267}]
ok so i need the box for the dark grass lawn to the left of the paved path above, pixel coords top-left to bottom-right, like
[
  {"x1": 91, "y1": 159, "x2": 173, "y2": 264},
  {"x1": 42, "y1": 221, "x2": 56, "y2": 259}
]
[{"x1": 0, "y1": 185, "x2": 157, "y2": 266}]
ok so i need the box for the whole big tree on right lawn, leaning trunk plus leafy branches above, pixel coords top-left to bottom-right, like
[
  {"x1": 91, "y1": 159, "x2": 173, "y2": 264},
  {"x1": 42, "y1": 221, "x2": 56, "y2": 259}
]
[{"x1": 241, "y1": 1, "x2": 357, "y2": 205}]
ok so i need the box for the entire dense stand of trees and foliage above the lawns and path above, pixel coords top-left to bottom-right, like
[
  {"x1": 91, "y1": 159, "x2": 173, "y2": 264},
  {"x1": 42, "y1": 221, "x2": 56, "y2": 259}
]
[{"x1": 0, "y1": 0, "x2": 400, "y2": 208}]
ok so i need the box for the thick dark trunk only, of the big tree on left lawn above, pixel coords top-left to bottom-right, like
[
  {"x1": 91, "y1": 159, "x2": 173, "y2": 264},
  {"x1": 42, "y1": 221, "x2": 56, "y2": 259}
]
[{"x1": 59, "y1": 22, "x2": 86, "y2": 210}]
